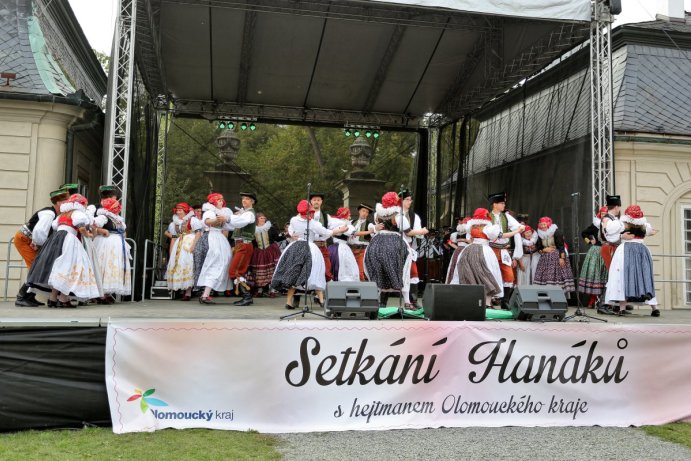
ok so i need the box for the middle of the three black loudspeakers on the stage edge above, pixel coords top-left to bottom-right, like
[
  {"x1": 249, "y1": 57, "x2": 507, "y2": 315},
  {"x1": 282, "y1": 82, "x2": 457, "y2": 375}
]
[{"x1": 422, "y1": 283, "x2": 485, "y2": 321}]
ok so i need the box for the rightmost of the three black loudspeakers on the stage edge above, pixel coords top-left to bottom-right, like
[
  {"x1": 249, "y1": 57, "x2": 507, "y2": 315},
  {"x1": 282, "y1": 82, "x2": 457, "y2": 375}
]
[{"x1": 509, "y1": 285, "x2": 567, "y2": 322}]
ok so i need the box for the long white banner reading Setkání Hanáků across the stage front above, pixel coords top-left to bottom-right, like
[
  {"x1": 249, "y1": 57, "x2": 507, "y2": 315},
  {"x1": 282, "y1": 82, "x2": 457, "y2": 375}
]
[{"x1": 106, "y1": 320, "x2": 691, "y2": 433}]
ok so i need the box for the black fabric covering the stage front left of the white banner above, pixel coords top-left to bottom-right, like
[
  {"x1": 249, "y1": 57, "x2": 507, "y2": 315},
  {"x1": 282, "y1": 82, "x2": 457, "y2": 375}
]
[{"x1": 0, "y1": 327, "x2": 111, "y2": 432}]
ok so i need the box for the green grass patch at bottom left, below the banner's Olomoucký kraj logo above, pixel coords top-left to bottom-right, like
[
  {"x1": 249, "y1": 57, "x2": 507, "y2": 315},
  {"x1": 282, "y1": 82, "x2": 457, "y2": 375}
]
[{"x1": 0, "y1": 428, "x2": 281, "y2": 461}]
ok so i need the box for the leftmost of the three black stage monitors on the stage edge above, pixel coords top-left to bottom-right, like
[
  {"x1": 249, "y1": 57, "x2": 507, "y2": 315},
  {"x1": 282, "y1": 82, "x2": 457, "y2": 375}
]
[{"x1": 324, "y1": 282, "x2": 379, "y2": 320}]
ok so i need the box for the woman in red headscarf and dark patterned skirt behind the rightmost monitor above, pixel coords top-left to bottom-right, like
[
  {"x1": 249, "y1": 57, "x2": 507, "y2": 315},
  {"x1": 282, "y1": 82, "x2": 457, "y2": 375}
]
[{"x1": 533, "y1": 216, "x2": 575, "y2": 293}]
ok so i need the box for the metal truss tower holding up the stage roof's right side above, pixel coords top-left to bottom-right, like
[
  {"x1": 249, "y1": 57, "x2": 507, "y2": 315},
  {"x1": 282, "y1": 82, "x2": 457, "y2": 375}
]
[{"x1": 590, "y1": 0, "x2": 614, "y2": 210}]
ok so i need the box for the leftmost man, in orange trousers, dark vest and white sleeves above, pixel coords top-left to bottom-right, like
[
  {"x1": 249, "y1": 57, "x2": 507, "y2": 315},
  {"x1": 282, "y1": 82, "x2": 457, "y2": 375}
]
[{"x1": 14, "y1": 189, "x2": 70, "y2": 307}]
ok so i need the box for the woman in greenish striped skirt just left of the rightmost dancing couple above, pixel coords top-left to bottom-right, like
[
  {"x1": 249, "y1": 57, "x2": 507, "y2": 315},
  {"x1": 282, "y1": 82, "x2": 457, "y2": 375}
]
[{"x1": 578, "y1": 206, "x2": 608, "y2": 308}]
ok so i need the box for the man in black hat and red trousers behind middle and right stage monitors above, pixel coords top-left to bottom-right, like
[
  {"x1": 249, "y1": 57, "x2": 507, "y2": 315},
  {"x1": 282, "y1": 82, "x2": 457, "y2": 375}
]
[{"x1": 488, "y1": 192, "x2": 523, "y2": 309}]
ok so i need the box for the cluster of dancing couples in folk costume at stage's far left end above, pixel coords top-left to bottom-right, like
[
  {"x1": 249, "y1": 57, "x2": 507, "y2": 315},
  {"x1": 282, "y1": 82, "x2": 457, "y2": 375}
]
[{"x1": 14, "y1": 184, "x2": 132, "y2": 308}]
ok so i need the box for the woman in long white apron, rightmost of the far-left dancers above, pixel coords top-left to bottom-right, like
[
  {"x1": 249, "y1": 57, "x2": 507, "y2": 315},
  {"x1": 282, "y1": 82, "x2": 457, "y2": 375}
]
[{"x1": 94, "y1": 197, "x2": 132, "y2": 296}]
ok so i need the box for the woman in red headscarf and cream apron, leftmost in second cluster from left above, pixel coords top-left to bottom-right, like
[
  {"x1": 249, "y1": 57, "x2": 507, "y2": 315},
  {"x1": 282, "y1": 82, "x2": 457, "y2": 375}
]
[{"x1": 166, "y1": 202, "x2": 201, "y2": 301}]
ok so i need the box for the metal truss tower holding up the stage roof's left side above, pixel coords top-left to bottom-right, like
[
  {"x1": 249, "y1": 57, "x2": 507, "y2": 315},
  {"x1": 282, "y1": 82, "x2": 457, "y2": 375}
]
[{"x1": 105, "y1": 0, "x2": 137, "y2": 217}]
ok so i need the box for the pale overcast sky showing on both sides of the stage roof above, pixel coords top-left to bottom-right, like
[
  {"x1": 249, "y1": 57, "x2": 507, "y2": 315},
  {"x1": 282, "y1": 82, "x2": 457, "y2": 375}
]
[{"x1": 69, "y1": 0, "x2": 691, "y2": 54}]
